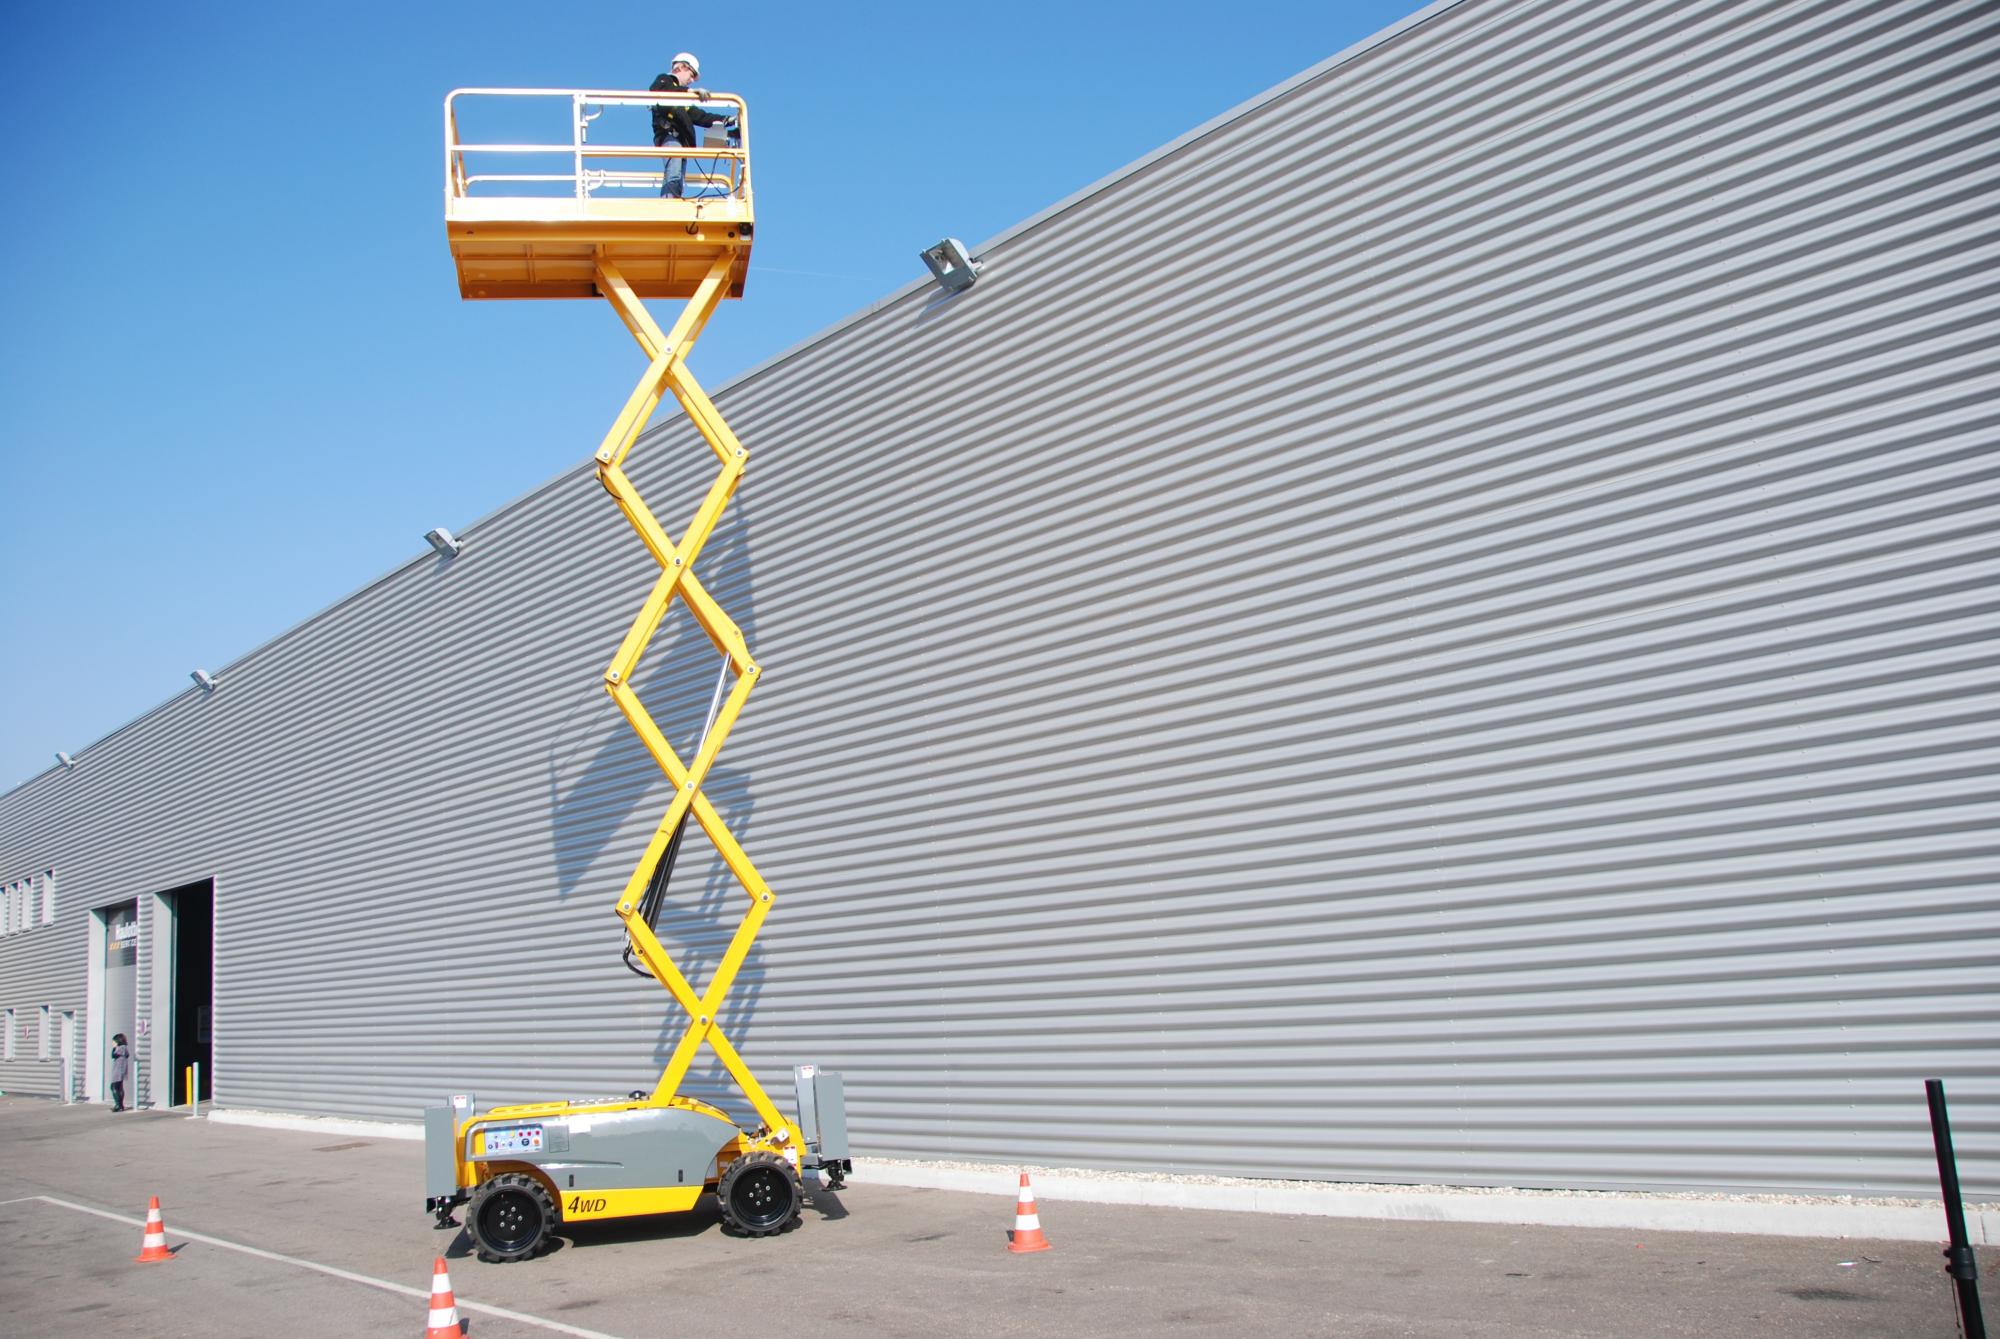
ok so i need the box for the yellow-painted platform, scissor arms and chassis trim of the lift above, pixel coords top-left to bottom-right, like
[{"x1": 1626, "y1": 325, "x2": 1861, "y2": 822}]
[{"x1": 446, "y1": 90, "x2": 806, "y2": 1221}]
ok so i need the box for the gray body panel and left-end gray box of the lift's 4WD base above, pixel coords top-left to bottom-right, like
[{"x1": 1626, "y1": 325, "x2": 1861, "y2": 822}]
[{"x1": 424, "y1": 1107, "x2": 740, "y2": 1199}]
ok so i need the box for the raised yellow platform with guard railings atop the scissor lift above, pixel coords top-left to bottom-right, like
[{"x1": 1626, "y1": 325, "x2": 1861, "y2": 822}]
[{"x1": 444, "y1": 88, "x2": 756, "y2": 300}]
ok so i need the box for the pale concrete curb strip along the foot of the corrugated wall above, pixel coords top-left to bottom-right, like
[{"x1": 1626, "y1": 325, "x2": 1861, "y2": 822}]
[{"x1": 208, "y1": 1109, "x2": 2000, "y2": 1245}]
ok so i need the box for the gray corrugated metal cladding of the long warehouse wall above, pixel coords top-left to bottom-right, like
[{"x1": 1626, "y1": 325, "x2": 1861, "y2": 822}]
[{"x1": 0, "y1": 0, "x2": 2000, "y2": 1197}]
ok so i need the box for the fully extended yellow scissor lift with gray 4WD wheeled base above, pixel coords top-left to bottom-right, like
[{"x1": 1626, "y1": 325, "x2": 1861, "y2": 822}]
[{"x1": 424, "y1": 88, "x2": 852, "y2": 1261}]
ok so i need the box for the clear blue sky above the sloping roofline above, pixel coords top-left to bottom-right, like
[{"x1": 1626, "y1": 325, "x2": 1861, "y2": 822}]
[{"x1": 0, "y1": 0, "x2": 1422, "y2": 789}]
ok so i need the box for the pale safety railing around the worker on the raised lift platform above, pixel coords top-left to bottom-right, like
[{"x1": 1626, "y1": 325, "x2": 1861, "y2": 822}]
[{"x1": 444, "y1": 88, "x2": 750, "y2": 206}]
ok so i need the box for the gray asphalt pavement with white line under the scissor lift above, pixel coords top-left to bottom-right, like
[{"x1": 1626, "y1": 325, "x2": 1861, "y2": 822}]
[{"x1": 0, "y1": 1097, "x2": 2000, "y2": 1339}]
